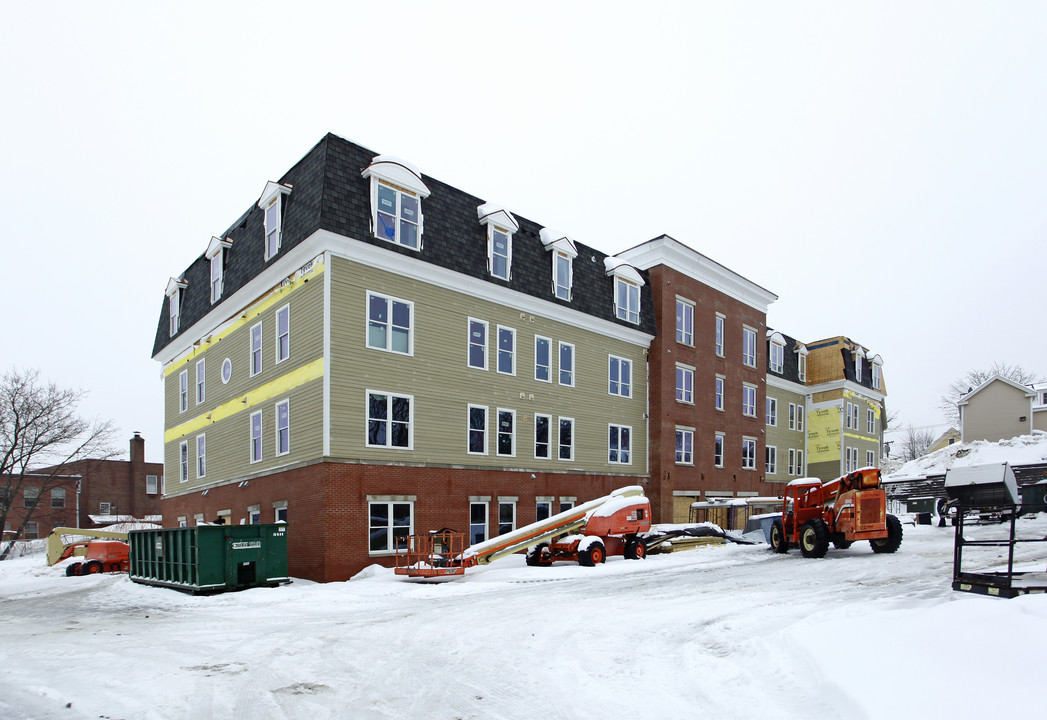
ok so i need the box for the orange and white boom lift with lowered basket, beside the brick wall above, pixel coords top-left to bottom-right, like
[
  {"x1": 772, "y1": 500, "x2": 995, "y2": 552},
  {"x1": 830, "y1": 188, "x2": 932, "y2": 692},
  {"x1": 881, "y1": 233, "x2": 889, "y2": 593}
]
[{"x1": 395, "y1": 486, "x2": 651, "y2": 578}]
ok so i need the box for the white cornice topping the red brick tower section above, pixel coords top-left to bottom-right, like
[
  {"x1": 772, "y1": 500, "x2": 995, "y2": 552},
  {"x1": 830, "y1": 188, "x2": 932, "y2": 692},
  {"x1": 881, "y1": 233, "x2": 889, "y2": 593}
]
[{"x1": 617, "y1": 235, "x2": 778, "y2": 314}]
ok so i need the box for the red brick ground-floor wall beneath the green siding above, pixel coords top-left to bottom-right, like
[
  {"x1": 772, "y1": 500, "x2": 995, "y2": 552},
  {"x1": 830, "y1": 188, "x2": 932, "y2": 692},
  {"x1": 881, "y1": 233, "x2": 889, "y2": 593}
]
[{"x1": 163, "y1": 463, "x2": 632, "y2": 582}]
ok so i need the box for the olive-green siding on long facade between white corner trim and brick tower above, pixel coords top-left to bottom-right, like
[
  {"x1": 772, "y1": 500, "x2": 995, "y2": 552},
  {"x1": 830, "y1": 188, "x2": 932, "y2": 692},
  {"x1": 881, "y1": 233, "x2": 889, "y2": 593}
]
[{"x1": 329, "y1": 258, "x2": 647, "y2": 475}]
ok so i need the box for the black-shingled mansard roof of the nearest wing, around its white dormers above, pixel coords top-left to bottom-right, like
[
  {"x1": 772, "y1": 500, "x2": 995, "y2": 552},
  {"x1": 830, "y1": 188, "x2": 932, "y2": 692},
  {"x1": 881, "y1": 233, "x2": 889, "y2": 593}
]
[{"x1": 153, "y1": 133, "x2": 655, "y2": 357}]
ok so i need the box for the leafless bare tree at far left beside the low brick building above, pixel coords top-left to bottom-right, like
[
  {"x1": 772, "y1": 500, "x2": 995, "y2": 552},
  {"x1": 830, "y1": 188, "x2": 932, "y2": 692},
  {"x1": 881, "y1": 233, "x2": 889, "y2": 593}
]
[{"x1": 0, "y1": 369, "x2": 117, "y2": 560}]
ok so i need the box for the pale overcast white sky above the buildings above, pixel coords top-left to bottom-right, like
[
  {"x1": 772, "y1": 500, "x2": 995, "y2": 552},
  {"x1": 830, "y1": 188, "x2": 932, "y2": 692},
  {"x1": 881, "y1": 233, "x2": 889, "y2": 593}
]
[{"x1": 0, "y1": 0, "x2": 1047, "y2": 460}]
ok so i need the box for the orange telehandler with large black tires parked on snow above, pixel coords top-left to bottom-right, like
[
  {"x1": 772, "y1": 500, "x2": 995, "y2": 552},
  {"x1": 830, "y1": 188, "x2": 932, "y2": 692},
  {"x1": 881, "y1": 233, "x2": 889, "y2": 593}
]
[{"x1": 771, "y1": 468, "x2": 901, "y2": 558}]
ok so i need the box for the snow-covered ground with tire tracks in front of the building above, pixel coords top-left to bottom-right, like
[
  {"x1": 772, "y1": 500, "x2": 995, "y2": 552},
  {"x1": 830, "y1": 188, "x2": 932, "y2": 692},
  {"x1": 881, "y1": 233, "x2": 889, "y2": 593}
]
[{"x1": 0, "y1": 514, "x2": 1047, "y2": 720}]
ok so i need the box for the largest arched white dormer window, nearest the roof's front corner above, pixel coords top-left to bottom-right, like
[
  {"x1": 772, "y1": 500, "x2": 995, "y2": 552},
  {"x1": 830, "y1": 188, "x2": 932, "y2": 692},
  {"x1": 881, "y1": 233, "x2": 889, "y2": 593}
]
[{"x1": 363, "y1": 155, "x2": 429, "y2": 250}]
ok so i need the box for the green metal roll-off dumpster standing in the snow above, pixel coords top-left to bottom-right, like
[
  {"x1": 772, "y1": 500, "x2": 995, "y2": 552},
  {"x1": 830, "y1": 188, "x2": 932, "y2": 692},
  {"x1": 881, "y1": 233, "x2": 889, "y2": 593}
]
[{"x1": 128, "y1": 523, "x2": 291, "y2": 593}]
